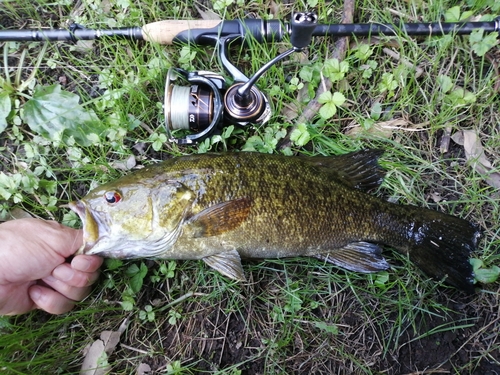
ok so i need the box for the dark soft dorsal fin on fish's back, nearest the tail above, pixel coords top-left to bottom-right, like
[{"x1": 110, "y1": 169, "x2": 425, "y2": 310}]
[{"x1": 304, "y1": 149, "x2": 385, "y2": 191}]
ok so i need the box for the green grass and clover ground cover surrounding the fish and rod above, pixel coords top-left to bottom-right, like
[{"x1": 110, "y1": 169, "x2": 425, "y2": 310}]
[{"x1": 0, "y1": 0, "x2": 500, "y2": 375}]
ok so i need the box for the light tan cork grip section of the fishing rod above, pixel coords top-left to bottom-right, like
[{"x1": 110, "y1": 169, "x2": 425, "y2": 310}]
[{"x1": 142, "y1": 20, "x2": 221, "y2": 44}]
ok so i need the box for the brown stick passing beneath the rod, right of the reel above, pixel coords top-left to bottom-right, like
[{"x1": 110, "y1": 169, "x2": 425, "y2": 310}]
[{"x1": 278, "y1": 0, "x2": 354, "y2": 150}]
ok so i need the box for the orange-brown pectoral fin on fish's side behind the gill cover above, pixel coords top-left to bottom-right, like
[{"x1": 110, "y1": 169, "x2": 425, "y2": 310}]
[{"x1": 187, "y1": 198, "x2": 252, "y2": 238}]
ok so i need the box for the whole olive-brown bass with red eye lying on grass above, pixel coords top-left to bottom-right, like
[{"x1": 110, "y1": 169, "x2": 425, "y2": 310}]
[{"x1": 67, "y1": 149, "x2": 481, "y2": 293}]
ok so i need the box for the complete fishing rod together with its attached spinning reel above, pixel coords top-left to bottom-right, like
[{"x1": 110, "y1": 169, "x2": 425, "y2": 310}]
[{"x1": 0, "y1": 13, "x2": 500, "y2": 145}]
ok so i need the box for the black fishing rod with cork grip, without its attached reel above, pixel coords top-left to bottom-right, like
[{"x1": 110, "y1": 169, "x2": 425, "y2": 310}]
[{"x1": 0, "y1": 17, "x2": 500, "y2": 45}]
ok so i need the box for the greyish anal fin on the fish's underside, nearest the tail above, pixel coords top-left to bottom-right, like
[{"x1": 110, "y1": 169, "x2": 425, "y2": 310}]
[{"x1": 314, "y1": 242, "x2": 389, "y2": 273}]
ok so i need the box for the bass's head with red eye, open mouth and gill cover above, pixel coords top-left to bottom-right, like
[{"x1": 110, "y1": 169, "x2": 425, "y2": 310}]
[{"x1": 67, "y1": 176, "x2": 195, "y2": 259}]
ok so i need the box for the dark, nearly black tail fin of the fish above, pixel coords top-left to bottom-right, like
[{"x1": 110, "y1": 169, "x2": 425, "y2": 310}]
[{"x1": 402, "y1": 208, "x2": 481, "y2": 293}]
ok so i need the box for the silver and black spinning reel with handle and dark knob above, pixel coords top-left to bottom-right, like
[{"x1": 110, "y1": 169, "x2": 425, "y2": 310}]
[{"x1": 164, "y1": 13, "x2": 318, "y2": 145}]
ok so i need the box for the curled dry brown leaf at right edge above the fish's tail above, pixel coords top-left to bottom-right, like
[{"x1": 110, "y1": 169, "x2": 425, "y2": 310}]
[{"x1": 451, "y1": 130, "x2": 500, "y2": 188}]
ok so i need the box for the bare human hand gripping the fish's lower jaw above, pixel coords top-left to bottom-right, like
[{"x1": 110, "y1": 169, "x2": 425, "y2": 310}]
[{"x1": 0, "y1": 219, "x2": 102, "y2": 315}]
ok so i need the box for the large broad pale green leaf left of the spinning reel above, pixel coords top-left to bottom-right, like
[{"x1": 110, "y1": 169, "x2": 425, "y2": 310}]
[{"x1": 22, "y1": 85, "x2": 104, "y2": 146}]
